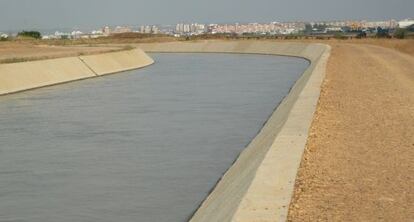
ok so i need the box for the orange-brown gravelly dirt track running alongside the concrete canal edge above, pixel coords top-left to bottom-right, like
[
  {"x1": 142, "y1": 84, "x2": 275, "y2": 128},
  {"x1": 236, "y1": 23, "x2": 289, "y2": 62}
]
[{"x1": 289, "y1": 44, "x2": 414, "y2": 221}]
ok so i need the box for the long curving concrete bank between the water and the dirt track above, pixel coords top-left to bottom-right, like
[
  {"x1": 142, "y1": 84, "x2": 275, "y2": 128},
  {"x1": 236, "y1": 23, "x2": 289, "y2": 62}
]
[{"x1": 139, "y1": 41, "x2": 330, "y2": 222}]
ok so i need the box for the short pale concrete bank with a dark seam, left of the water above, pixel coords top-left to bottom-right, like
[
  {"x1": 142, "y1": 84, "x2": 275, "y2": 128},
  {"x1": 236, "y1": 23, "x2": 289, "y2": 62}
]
[{"x1": 0, "y1": 49, "x2": 154, "y2": 95}]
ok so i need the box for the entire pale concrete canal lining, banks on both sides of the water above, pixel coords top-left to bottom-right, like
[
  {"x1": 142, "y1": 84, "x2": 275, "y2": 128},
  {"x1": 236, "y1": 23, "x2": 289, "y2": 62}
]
[{"x1": 0, "y1": 41, "x2": 330, "y2": 222}]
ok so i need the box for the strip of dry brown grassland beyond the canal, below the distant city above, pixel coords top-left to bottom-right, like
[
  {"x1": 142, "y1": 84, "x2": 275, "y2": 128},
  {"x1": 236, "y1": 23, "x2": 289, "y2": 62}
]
[{"x1": 0, "y1": 36, "x2": 414, "y2": 63}]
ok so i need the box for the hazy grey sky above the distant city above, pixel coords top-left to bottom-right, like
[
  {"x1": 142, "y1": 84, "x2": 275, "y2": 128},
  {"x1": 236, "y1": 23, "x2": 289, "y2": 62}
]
[{"x1": 0, "y1": 0, "x2": 414, "y2": 30}]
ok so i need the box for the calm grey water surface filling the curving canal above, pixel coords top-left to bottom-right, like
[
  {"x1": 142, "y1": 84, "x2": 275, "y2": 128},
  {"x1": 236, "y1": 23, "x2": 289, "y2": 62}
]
[{"x1": 0, "y1": 54, "x2": 308, "y2": 222}]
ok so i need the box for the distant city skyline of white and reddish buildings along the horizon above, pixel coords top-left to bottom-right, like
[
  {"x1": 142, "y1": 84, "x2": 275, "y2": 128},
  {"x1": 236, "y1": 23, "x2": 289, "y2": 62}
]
[{"x1": 11, "y1": 19, "x2": 414, "y2": 39}]
